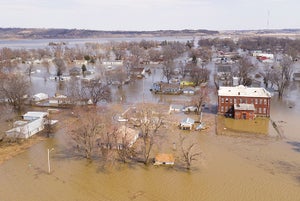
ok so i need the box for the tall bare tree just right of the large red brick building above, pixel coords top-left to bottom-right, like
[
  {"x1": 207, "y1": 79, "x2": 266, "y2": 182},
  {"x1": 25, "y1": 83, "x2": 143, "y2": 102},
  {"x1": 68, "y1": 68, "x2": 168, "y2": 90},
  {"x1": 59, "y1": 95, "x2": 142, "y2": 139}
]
[{"x1": 271, "y1": 56, "x2": 293, "y2": 99}]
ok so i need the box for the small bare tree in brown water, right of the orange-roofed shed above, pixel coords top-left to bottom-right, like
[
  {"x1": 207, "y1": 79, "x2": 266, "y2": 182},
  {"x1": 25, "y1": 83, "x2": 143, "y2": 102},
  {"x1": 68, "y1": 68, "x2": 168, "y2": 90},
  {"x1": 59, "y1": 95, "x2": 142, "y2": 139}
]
[{"x1": 179, "y1": 135, "x2": 201, "y2": 170}]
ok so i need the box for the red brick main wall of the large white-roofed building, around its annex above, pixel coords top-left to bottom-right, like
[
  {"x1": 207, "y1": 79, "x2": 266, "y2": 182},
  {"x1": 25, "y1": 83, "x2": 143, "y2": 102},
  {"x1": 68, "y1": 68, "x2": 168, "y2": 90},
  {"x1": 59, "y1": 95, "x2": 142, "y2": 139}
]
[{"x1": 218, "y1": 96, "x2": 271, "y2": 117}]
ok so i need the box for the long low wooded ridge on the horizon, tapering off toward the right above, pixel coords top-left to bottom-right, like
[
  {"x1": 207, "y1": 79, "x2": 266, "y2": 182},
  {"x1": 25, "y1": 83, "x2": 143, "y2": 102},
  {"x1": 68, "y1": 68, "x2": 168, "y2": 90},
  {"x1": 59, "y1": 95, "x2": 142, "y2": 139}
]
[{"x1": 0, "y1": 28, "x2": 219, "y2": 39}]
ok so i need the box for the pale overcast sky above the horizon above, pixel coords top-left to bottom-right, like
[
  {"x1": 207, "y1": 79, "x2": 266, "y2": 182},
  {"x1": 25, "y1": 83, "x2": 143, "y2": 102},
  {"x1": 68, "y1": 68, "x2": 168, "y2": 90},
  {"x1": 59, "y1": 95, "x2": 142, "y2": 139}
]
[{"x1": 0, "y1": 0, "x2": 300, "y2": 31}]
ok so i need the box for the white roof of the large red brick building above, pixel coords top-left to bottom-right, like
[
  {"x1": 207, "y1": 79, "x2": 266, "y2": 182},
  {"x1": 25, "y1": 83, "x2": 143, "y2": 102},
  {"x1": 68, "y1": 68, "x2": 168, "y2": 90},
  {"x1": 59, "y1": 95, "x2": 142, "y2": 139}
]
[{"x1": 218, "y1": 85, "x2": 271, "y2": 98}]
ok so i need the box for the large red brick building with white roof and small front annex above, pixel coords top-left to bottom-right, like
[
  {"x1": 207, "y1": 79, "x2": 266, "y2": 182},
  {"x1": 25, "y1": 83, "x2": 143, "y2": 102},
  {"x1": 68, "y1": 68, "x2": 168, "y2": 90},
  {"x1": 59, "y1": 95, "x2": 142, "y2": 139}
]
[{"x1": 218, "y1": 85, "x2": 271, "y2": 119}]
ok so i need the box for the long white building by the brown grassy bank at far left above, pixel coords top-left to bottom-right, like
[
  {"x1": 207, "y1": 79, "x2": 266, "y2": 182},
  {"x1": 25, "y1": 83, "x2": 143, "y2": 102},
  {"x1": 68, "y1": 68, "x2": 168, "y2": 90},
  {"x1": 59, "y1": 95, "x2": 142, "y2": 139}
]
[{"x1": 5, "y1": 112, "x2": 48, "y2": 138}]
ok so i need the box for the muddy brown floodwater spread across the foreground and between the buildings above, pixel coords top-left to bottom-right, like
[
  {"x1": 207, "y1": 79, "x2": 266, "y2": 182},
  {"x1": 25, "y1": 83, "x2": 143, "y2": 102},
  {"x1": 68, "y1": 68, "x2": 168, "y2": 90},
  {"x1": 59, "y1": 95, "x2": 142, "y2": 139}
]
[{"x1": 0, "y1": 40, "x2": 300, "y2": 201}]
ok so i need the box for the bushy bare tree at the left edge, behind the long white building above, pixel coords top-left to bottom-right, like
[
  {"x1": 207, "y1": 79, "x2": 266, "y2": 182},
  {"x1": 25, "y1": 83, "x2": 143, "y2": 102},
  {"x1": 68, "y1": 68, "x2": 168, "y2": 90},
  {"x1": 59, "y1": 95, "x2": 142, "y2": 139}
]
[{"x1": 0, "y1": 74, "x2": 30, "y2": 112}]
